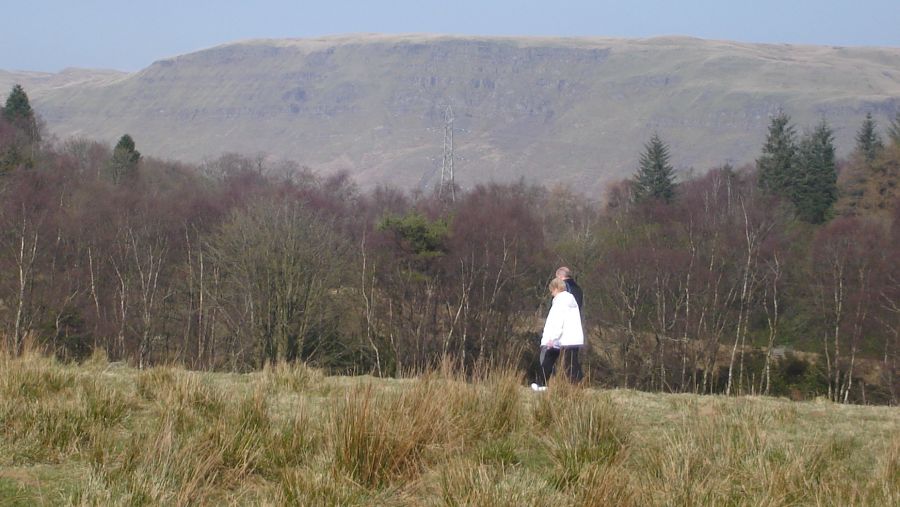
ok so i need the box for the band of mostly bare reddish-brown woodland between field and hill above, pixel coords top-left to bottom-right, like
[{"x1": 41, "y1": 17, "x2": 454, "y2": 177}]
[{"x1": 0, "y1": 86, "x2": 900, "y2": 403}]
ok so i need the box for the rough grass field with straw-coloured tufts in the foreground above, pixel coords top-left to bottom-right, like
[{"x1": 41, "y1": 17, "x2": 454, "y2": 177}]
[{"x1": 0, "y1": 355, "x2": 900, "y2": 506}]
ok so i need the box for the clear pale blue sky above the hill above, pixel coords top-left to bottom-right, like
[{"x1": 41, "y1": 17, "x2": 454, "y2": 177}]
[{"x1": 0, "y1": 0, "x2": 900, "y2": 72}]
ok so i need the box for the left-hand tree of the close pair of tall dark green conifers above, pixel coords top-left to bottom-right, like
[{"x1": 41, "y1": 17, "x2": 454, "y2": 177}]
[{"x1": 756, "y1": 111, "x2": 797, "y2": 197}]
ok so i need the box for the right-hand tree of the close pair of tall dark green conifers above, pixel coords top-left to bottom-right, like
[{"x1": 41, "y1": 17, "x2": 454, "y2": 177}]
[{"x1": 791, "y1": 120, "x2": 838, "y2": 224}]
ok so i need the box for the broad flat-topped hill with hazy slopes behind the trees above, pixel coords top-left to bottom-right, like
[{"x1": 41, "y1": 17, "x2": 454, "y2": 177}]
[{"x1": 0, "y1": 35, "x2": 900, "y2": 195}]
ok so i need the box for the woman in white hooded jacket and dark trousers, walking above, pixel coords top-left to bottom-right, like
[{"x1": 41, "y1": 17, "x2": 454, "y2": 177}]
[{"x1": 531, "y1": 278, "x2": 584, "y2": 391}]
